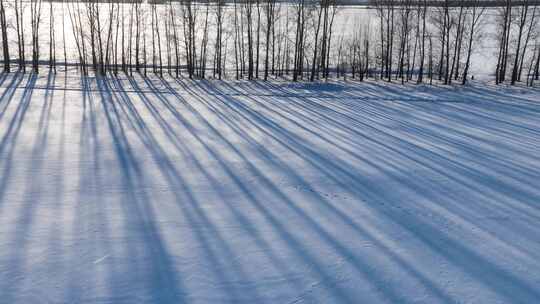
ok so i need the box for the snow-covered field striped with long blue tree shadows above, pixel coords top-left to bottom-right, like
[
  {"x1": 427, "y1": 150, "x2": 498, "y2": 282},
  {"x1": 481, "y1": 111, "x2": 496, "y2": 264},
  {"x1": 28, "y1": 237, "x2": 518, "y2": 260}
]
[{"x1": 0, "y1": 73, "x2": 540, "y2": 304}]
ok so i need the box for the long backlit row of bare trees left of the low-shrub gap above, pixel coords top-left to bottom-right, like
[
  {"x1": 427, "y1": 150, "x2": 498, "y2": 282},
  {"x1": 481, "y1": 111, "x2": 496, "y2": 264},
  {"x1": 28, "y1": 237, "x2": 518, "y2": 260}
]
[{"x1": 0, "y1": 0, "x2": 337, "y2": 80}]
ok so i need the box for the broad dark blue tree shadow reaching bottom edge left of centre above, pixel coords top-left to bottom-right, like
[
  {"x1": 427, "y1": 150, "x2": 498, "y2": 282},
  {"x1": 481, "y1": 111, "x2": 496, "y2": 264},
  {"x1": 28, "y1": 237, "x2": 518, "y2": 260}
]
[{"x1": 87, "y1": 77, "x2": 189, "y2": 303}]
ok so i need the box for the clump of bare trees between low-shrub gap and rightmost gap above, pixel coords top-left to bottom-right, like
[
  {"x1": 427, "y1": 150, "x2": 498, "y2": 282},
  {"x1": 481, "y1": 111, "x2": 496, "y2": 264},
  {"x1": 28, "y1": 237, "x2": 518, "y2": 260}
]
[{"x1": 374, "y1": 0, "x2": 486, "y2": 84}]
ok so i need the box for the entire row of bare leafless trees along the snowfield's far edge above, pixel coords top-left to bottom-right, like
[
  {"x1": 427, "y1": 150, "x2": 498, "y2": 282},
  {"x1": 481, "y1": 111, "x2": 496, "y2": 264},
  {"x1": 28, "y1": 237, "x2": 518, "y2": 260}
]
[{"x1": 0, "y1": 0, "x2": 540, "y2": 85}]
